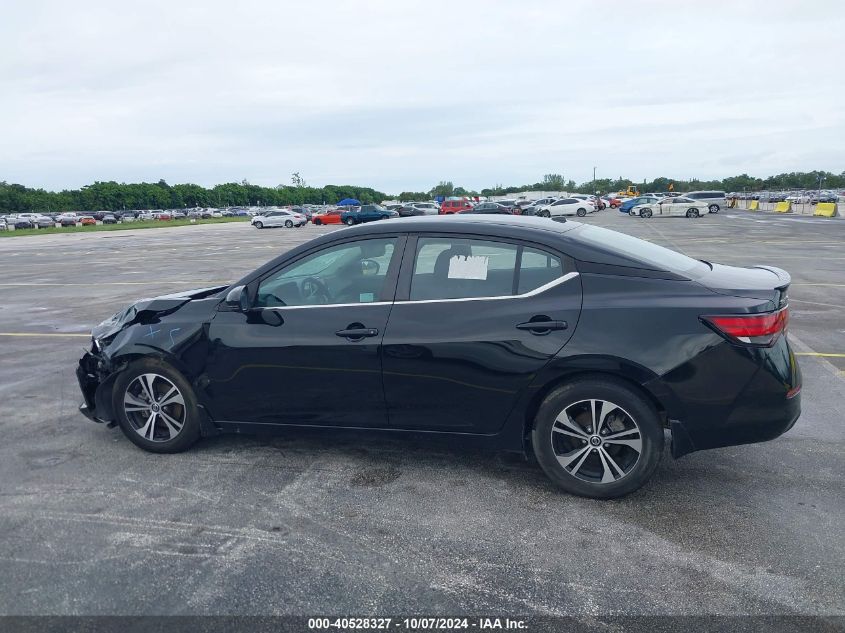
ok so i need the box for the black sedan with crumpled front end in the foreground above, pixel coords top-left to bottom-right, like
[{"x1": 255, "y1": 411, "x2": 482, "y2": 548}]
[{"x1": 77, "y1": 215, "x2": 801, "y2": 498}]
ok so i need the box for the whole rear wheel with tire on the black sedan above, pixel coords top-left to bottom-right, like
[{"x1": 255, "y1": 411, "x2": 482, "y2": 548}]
[{"x1": 531, "y1": 376, "x2": 664, "y2": 499}]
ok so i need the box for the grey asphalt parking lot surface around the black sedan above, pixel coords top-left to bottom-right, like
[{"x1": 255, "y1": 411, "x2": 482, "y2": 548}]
[{"x1": 0, "y1": 210, "x2": 845, "y2": 616}]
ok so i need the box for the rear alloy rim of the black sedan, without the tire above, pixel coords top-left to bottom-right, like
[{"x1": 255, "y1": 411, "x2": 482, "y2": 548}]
[{"x1": 550, "y1": 400, "x2": 643, "y2": 484}]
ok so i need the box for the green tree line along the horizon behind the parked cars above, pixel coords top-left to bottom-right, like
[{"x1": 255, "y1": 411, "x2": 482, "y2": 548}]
[{"x1": 0, "y1": 171, "x2": 845, "y2": 213}]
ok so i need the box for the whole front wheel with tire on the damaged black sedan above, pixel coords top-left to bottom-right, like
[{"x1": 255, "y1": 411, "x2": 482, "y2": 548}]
[{"x1": 112, "y1": 358, "x2": 200, "y2": 453}]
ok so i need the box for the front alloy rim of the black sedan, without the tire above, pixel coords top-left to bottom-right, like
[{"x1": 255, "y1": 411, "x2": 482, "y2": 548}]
[{"x1": 123, "y1": 373, "x2": 187, "y2": 442}]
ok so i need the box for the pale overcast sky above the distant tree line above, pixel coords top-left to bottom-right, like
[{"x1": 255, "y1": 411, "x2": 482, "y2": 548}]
[{"x1": 0, "y1": 0, "x2": 845, "y2": 193}]
